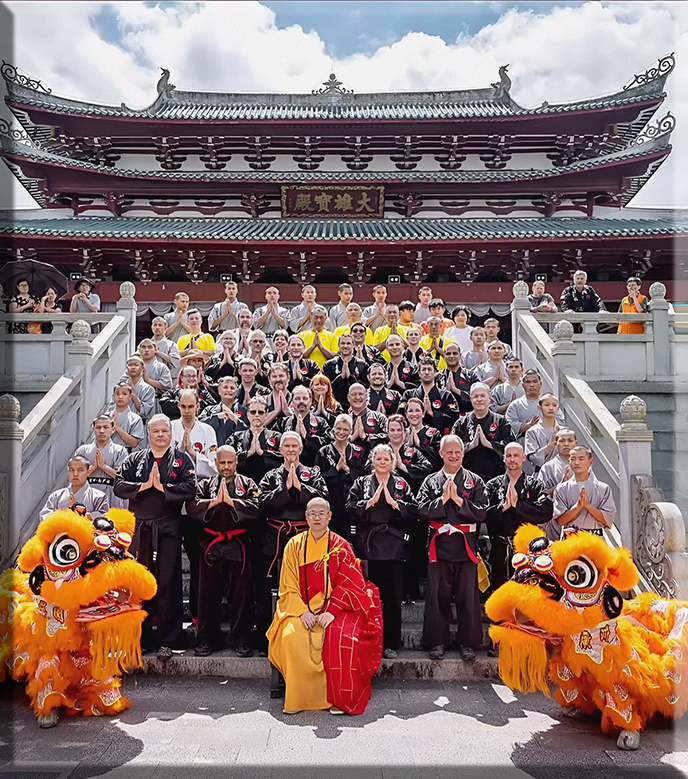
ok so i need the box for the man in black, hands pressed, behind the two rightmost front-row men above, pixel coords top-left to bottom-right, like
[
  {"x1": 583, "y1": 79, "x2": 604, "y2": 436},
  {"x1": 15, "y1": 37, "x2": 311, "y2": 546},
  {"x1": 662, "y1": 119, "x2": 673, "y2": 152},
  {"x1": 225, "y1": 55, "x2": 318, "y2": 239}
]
[{"x1": 452, "y1": 382, "x2": 513, "y2": 481}]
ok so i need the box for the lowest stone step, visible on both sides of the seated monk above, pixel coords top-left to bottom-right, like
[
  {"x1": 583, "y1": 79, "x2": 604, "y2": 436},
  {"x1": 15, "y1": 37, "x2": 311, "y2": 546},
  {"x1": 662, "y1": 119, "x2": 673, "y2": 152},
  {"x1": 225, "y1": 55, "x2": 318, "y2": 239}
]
[{"x1": 140, "y1": 649, "x2": 499, "y2": 680}]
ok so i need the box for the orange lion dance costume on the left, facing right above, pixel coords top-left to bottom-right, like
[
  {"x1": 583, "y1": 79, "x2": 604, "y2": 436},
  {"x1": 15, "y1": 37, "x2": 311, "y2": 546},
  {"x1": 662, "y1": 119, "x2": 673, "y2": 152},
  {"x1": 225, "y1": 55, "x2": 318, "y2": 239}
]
[{"x1": 0, "y1": 509, "x2": 156, "y2": 727}]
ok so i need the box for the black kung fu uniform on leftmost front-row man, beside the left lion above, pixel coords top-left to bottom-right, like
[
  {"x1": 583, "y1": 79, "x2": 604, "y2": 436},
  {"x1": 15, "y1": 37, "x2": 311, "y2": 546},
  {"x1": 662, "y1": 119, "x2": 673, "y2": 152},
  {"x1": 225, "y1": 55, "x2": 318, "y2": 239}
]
[{"x1": 114, "y1": 448, "x2": 196, "y2": 649}]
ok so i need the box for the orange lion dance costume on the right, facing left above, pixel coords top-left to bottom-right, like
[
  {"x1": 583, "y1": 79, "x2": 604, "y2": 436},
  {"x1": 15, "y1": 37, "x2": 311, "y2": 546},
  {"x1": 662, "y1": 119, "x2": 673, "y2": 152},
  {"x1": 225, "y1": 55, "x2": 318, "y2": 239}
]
[{"x1": 486, "y1": 525, "x2": 688, "y2": 749}]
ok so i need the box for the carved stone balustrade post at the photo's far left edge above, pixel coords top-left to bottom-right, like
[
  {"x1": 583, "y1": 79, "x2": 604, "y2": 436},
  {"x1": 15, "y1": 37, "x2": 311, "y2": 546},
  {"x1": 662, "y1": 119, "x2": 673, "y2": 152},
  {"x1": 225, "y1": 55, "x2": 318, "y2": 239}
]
[{"x1": 0, "y1": 395, "x2": 24, "y2": 567}]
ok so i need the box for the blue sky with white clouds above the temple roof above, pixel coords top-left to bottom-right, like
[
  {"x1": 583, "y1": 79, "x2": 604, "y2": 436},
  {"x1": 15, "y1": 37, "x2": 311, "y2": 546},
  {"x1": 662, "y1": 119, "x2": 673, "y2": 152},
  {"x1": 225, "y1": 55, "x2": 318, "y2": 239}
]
[{"x1": 0, "y1": 0, "x2": 688, "y2": 208}]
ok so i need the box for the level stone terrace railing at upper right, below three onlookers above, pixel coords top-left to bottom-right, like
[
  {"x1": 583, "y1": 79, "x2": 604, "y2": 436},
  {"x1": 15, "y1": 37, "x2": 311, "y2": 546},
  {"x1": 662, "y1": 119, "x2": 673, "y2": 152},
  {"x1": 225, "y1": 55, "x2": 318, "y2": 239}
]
[{"x1": 512, "y1": 282, "x2": 688, "y2": 381}]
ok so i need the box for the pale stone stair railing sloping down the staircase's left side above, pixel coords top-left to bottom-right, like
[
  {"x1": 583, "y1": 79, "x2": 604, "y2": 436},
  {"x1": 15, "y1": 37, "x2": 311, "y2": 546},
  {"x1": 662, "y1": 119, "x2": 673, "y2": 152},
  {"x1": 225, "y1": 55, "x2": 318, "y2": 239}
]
[{"x1": 0, "y1": 282, "x2": 136, "y2": 563}]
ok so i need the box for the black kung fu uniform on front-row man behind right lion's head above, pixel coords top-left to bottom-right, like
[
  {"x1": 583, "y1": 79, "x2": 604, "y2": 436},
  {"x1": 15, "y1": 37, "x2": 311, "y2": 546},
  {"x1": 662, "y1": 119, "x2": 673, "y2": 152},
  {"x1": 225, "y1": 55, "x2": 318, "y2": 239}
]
[{"x1": 485, "y1": 473, "x2": 553, "y2": 590}]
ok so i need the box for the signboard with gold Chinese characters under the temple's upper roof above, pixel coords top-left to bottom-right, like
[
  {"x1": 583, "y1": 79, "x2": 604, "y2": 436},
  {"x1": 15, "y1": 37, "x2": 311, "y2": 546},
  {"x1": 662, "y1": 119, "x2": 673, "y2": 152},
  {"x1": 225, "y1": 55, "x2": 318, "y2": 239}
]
[{"x1": 282, "y1": 184, "x2": 385, "y2": 219}]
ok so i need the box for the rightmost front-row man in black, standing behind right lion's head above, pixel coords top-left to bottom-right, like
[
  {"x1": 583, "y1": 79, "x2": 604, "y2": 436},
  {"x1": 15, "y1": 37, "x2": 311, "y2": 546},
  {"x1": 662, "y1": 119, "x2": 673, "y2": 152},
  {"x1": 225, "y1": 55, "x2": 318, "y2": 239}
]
[{"x1": 485, "y1": 441, "x2": 552, "y2": 590}]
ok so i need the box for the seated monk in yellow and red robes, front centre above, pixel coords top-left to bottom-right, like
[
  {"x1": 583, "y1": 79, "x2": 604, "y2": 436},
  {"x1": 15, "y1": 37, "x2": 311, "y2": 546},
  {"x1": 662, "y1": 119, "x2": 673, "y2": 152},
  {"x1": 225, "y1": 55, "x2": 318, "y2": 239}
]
[{"x1": 267, "y1": 498, "x2": 382, "y2": 714}]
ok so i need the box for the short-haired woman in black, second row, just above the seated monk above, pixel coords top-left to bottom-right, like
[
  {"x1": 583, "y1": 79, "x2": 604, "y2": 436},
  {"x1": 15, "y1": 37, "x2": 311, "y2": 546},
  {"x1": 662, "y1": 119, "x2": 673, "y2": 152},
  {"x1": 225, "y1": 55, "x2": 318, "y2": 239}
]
[{"x1": 315, "y1": 414, "x2": 368, "y2": 543}]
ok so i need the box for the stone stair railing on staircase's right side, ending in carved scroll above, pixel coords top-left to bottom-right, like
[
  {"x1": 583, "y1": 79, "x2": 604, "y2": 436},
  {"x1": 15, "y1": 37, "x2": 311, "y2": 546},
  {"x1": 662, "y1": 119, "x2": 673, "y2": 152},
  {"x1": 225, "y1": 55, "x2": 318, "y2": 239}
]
[{"x1": 513, "y1": 282, "x2": 688, "y2": 598}]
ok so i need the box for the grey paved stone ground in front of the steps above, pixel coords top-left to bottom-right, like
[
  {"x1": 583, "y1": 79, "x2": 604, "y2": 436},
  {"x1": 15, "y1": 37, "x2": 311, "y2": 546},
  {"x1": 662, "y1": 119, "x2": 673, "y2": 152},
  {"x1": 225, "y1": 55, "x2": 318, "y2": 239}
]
[{"x1": 0, "y1": 675, "x2": 688, "y2": 779}]
